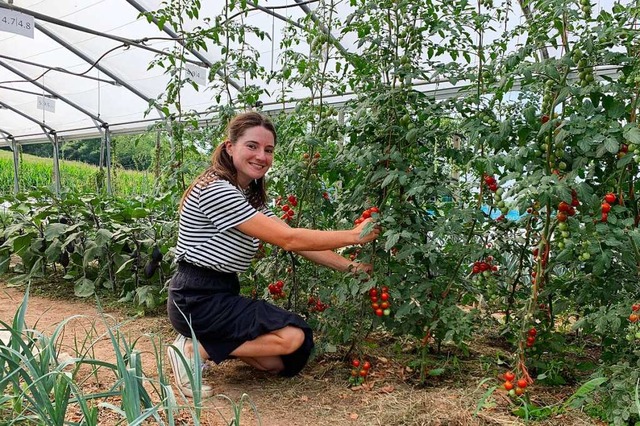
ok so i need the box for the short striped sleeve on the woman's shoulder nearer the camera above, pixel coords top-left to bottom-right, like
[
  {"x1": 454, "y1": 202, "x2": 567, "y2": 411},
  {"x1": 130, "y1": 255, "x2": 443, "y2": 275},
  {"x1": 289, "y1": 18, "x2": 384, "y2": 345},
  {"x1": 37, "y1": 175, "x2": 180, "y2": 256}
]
[{"x1": 198, "y1": 180, "x2": 257, "y2": 232}]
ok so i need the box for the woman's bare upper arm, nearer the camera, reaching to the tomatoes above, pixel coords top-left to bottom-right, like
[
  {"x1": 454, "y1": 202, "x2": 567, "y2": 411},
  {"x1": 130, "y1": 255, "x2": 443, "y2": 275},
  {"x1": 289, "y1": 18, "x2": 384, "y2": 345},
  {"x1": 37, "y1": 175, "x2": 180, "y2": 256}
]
[{"x1": 236, "y1": 212, "x2": 380, "y2": 251}]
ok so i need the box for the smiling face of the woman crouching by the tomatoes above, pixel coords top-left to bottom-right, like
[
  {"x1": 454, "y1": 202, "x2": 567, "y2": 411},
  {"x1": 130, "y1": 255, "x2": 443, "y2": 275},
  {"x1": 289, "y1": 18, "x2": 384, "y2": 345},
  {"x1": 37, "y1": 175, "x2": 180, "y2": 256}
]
[{"x1": 225, "y1": 126, "x2": 275, "y2": 188}]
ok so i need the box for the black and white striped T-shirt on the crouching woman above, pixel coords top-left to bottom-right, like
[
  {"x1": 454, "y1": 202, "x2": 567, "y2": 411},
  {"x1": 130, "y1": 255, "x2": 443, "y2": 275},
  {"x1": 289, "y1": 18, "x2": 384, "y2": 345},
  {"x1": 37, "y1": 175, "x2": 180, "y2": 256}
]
[{"x1": 176, "y1": 179, "x2": 274, "y2": 272}]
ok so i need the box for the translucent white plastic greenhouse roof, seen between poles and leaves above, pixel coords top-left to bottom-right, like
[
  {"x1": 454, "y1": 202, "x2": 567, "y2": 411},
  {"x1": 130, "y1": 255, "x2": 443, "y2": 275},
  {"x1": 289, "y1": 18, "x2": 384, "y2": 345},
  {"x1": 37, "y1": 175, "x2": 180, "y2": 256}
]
[{"x1": 0, "y1": 0, "x2": 612, "y2": 146}]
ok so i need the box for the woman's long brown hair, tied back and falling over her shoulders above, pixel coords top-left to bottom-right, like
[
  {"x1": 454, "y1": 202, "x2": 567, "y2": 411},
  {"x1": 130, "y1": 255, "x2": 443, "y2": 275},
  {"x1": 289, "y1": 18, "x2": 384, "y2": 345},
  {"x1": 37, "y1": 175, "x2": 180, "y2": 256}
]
[{"x1": 180, "y1": 111, "x2": 277, "y2": 210}]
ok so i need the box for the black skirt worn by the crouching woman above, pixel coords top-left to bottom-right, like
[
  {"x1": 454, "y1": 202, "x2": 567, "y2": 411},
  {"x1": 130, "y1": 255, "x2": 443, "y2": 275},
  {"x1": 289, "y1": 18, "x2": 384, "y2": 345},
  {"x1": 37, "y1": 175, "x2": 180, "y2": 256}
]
[{"x1": 167, "y1": 262, "x2": 313, "y2": 376}]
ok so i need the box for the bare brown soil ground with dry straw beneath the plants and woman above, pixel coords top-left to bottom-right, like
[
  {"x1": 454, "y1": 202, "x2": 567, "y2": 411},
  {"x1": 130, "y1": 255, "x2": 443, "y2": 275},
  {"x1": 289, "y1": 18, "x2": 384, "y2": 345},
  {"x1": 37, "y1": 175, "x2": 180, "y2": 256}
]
[{"x1": 0, "y1": 281, "x2": 601, "y2": 426}]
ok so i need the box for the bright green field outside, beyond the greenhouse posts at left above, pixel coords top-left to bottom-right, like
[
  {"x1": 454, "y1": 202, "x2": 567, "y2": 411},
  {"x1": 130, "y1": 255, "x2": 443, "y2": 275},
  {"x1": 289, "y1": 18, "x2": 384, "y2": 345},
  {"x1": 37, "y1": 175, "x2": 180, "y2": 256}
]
[{"x1": 0, "y1": 150, "x2": 155, "y2": 195}]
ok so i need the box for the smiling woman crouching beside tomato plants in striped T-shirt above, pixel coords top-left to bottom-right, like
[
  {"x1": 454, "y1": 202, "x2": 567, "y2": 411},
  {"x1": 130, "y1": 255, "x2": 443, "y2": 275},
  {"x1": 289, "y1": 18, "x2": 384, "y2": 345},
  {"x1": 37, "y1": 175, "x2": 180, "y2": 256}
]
[{"x1": 167, "y1": 112, "x2": 380, "y2": 396}]
